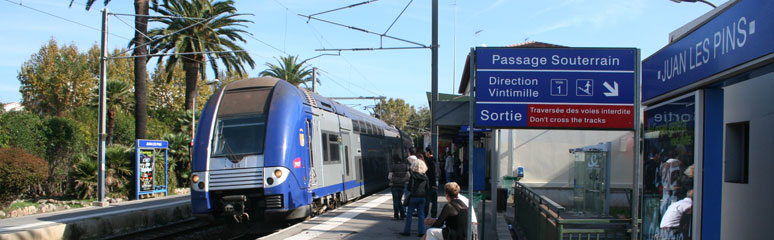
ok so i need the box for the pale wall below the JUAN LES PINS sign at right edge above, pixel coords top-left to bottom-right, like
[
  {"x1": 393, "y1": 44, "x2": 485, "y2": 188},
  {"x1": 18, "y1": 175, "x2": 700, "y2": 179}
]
[{"x1": 720, "y1": 70, "x2": 774, "y2": 239}]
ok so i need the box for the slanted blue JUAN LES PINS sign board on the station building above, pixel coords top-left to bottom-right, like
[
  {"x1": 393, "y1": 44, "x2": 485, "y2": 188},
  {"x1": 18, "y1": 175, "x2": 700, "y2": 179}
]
[{"x1": 642, "y1": 0, "x2": 774, "y2": 101}]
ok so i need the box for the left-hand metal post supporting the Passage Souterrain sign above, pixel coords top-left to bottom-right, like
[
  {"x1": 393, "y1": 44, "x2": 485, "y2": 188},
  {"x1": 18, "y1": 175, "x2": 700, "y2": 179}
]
[{"x1": 466, "y1": 48, "x2": 476, "y2": 240}]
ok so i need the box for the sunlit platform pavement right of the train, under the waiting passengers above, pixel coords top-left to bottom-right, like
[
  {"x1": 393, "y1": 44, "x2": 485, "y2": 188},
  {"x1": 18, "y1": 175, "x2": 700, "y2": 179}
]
[{"x1": 260, "y1": 189, "x2": 511, "y2": 240}]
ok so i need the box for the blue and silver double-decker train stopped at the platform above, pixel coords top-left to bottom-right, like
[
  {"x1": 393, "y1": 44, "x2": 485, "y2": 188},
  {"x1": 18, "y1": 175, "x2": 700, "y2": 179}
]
[{"x1": 191, "y1": 77, "x2": 411, "y2": 221}]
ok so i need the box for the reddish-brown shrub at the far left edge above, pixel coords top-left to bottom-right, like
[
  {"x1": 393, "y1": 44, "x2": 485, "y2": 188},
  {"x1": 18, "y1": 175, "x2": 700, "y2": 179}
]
[{"x1": 0, "y1": 148, "x2": 48, "y2": 207}]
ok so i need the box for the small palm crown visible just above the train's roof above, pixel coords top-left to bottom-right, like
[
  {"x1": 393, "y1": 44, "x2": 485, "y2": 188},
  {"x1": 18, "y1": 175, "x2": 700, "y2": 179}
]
[{"x1": 260, "y1": 56, "x2": 312, "y2": 86}]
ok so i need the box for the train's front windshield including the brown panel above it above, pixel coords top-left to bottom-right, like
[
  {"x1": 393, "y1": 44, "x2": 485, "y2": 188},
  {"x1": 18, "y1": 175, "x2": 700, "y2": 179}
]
[{"x1": 212, "y1": 88, "x2": 271, "y2": 157}]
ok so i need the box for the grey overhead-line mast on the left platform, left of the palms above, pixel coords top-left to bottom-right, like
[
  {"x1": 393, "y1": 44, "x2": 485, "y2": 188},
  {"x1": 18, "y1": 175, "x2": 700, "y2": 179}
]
[{"x1": 97, "y1": 8, "x2": 108, "y2": 205}]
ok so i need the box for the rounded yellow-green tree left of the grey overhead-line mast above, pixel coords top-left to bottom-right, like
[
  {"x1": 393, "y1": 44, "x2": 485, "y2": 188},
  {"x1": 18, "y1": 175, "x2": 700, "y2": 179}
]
[{"x1": 17, "y1": 38, "x2": 96, "y2": 116}]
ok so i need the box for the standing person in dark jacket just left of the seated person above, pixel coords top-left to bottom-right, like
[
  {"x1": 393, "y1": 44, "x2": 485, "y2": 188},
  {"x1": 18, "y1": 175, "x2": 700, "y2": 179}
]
[{"x1": 400, "y1": 158, "x2": 430, "y2": 237}]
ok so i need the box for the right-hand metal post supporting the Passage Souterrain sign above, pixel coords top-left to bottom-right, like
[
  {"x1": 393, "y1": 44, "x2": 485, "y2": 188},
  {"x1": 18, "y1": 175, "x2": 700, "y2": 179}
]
[{"x1": 632, "y1": 49, "x2": 642, "y2": 240}]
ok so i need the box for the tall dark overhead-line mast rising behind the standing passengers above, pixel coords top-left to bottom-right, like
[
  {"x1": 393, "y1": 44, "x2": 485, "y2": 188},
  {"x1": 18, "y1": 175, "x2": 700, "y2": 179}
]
[{"x1": 430, "y1": 0, "x2": 438, "y2": 163}]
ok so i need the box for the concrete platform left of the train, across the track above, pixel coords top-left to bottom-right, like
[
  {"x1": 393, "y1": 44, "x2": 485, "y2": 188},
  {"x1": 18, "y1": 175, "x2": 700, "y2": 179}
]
[{"x1": 0, "y1": 195, "x2": 191, "y2": 240}]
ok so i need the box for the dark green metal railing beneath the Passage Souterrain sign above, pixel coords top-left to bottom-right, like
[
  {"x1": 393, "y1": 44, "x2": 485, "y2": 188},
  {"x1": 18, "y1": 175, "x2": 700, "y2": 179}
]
[{"x1": 514, "y1": 182, "x2": 631, "y2": 240}]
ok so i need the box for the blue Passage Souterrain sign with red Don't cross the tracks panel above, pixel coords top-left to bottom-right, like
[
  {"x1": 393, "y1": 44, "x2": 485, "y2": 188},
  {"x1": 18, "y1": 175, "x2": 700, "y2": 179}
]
[{"x1": 475, "y1": 48, "x2": 639, "y2": 129}]
